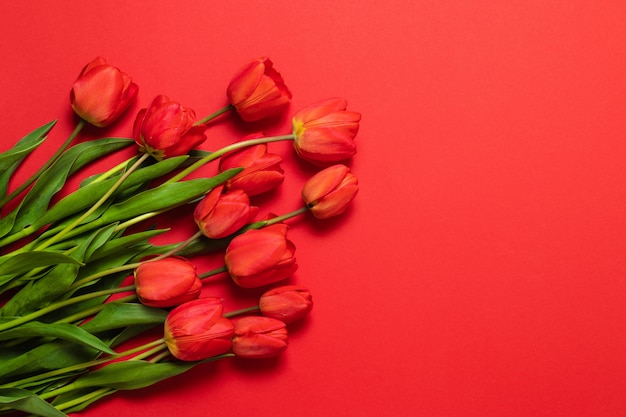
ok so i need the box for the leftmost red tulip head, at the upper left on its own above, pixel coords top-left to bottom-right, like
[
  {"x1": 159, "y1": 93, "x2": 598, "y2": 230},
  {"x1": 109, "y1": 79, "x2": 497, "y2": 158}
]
[{"x1": 70, "y1": 57, "x2": 139, "y2": 127}]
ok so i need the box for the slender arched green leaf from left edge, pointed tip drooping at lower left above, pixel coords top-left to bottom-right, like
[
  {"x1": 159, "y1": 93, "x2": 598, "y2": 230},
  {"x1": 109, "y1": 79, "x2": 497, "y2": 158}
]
[{"x1": 0, "y1": 321, "x2": 115, "y2": 355}]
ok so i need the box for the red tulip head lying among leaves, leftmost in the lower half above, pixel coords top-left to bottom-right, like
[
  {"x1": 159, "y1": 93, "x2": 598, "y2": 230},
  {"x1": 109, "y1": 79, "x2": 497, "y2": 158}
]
[{"x1": 135, "y1": 257, "x2": 202, "y2": 308}]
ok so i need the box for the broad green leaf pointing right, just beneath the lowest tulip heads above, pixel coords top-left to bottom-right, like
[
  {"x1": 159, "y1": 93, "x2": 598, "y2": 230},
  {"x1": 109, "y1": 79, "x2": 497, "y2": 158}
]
[{"x1": 67, "y1": 360, "x2": 201, "y2": 390}]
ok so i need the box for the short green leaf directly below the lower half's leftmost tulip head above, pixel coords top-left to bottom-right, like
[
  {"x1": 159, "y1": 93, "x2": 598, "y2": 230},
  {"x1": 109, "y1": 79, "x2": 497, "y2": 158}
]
[{"x1": 81, "y1": 303, "x2": 167, "y2": 335}]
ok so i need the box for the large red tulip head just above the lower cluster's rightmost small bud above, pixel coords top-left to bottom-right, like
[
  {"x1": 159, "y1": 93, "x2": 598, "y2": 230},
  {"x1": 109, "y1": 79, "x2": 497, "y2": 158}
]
[{"x1": 225, "y1": 223, "x2": 298, "y2": 288}]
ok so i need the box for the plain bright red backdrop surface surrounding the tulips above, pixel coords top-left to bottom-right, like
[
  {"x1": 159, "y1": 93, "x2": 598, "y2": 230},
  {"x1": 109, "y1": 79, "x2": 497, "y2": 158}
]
[{"x1": 0, "y1": 0, "x2": 626, "y2": 417}]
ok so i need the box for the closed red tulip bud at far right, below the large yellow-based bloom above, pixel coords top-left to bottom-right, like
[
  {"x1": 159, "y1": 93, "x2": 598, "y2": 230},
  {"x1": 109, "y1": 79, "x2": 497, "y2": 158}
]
[{"x1": 302, "y1": 165, "x2": 359, "y2": 219}]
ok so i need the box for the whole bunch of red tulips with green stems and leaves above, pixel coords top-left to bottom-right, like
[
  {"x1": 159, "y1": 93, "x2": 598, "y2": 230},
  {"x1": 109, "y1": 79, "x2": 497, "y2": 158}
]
[{"x1": 0, "y1": 58, "x2": 360, "y2": 416}]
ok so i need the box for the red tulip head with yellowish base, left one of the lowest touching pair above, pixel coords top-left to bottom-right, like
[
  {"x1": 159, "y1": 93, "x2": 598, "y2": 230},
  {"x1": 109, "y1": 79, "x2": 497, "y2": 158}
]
[{"x1": 165, "y1": 297, "x2": 234, "y2": 361}]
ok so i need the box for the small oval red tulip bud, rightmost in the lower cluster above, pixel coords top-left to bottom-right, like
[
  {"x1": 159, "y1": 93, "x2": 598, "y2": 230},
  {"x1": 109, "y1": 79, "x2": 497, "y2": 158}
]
[{"x1": 259, "y1": 285, "x2": 313, "y2": 323}]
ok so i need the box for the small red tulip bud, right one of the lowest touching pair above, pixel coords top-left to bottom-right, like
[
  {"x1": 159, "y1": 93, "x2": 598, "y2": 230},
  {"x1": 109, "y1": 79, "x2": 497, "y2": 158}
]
[{"x1": 233, "y1": 316, "x2": 287, "y2": 359}]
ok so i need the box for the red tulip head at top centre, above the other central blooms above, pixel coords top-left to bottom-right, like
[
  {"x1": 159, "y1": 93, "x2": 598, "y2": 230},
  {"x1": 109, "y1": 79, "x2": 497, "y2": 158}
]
[{"x1": 226, "y1": 58, "x2": 291, "y2": 122}]
